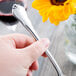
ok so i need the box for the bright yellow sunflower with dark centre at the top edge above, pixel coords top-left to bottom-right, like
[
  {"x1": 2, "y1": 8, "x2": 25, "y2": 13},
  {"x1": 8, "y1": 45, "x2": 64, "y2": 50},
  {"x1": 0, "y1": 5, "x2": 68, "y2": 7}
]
[{"x1": 32, "y1": 0, "x2": 76, "y2": 25}]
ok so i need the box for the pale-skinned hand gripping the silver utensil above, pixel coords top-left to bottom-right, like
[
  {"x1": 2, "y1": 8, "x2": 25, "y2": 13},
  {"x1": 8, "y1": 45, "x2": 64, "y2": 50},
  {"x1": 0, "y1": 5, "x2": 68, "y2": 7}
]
[{"x1": 0, "y1": 34, "x2": 49, "y2": 76}]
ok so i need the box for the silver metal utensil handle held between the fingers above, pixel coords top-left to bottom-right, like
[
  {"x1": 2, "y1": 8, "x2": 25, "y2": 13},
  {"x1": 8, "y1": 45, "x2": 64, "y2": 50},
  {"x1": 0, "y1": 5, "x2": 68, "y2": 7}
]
[{"x1": 12, "y1": 4, "x2": 64, "y2": 76}]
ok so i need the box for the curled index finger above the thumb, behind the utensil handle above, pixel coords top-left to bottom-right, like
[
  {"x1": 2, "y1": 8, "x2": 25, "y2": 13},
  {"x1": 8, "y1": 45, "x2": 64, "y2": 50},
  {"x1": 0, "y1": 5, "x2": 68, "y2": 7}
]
[{"x1": 2, "y1": 34, "x2": 35, "y2": 48}]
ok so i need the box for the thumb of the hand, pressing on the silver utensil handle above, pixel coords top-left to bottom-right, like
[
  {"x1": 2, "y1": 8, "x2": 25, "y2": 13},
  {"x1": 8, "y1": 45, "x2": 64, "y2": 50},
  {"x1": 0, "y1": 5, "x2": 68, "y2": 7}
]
[{"x1": 24, "y1": 38, "x2": 50, "y2": 63}]
